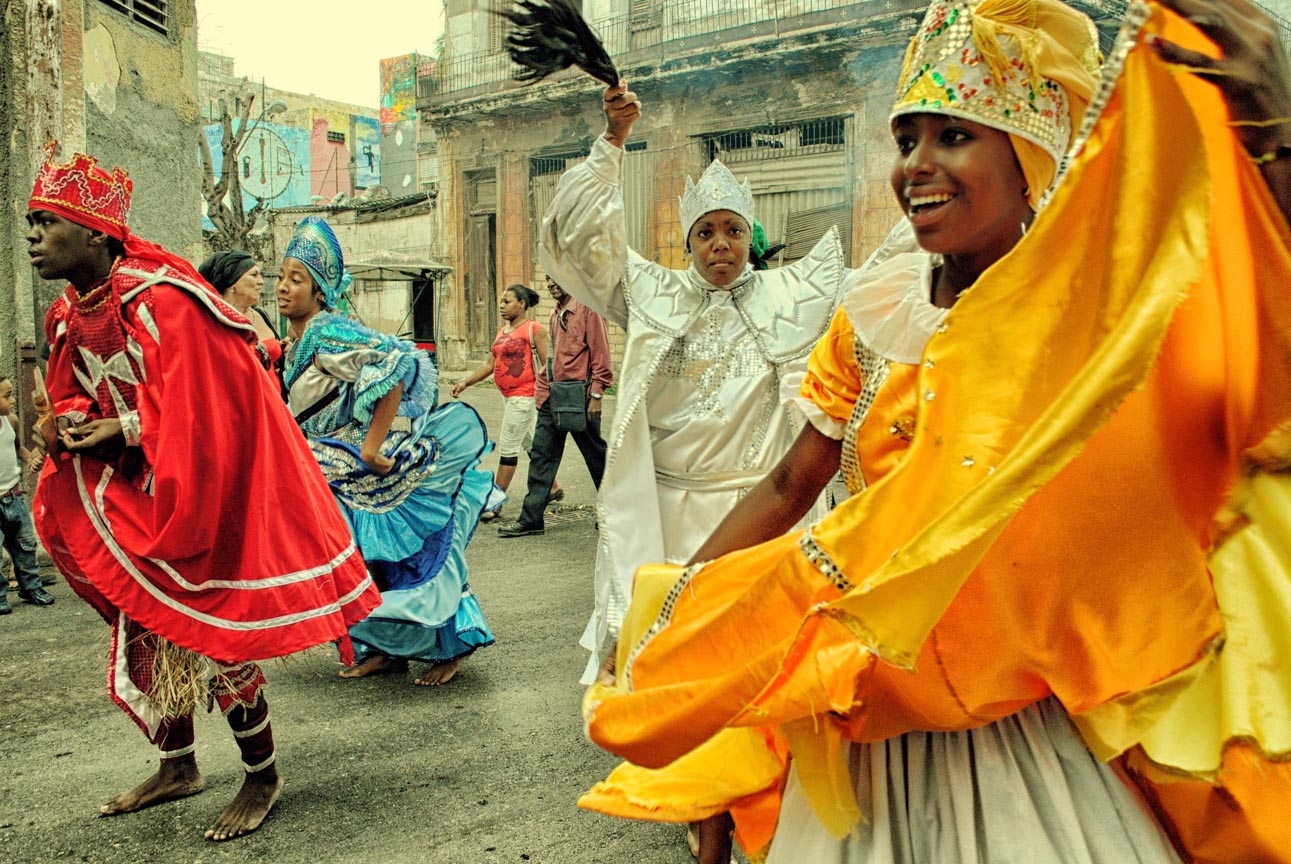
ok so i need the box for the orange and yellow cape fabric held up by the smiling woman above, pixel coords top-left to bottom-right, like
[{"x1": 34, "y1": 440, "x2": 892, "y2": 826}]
[{"x1": 590, "y1": 3, "x2": 1291, "y2": 836}]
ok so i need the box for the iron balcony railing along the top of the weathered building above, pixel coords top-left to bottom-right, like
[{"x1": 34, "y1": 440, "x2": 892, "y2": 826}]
[{"x1": 417, "y1": 0, "x2": 908, "y2": 102}]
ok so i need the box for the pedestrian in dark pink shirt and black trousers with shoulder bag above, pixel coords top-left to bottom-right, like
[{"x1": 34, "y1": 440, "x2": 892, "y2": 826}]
[{"x1": 497, "y1": 278, "x2": 615, "y2": 537}]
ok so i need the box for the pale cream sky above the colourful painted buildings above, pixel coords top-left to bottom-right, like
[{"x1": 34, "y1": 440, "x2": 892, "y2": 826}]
[{"x1": 198, "y1": 0, "x2": 444, "y2": 108}]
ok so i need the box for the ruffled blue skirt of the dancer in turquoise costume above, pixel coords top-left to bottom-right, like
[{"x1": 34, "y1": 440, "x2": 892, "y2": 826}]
[{"x1": 310, "y1": 402, "x2": 493, "y2": 663}]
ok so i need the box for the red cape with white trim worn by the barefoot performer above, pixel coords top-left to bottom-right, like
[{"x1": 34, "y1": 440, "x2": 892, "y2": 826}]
[{"x1": 34, "y1": 258, "x2": 380, "y2": 663}]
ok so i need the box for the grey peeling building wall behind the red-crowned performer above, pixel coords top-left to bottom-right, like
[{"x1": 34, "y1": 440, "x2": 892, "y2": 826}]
[{"x1": 0, "y1": 0, "x2": 201, "y2": 421}]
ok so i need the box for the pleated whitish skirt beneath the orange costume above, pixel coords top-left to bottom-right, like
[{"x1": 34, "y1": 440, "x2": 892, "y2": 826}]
[{"x1": 767, "y1": 699, "x2": 1180, "y2": 864}]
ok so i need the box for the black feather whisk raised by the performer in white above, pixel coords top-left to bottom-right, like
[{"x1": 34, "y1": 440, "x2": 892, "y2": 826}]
[{"x1": 494, "y1": 0, "x2": 618, "y2": 87}]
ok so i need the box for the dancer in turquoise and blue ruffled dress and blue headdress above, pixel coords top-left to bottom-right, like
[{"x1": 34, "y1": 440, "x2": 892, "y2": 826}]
[{"x1": 276, "y1": 216, "x2": 493, "y2": 686}]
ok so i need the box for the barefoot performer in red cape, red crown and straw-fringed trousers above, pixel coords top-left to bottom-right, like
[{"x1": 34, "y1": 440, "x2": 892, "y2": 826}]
[{"x1": 27, "y1": 143, "x2": 378, "y2": 841}]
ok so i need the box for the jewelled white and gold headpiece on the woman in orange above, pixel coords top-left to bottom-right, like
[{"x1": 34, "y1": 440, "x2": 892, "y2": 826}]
[{"x1": 891, "y1": 0, "x2": 1099, "y2": 164}]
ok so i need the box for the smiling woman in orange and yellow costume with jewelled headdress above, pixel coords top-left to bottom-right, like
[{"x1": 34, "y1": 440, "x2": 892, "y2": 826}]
[{"x1": 587, "y1": 0, "x2": 1291, "y2": 864}]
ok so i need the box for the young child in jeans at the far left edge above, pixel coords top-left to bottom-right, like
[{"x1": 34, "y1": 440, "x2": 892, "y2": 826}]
[{"x1": 0, "y1": 376, "x2": 54, "y2": 615}]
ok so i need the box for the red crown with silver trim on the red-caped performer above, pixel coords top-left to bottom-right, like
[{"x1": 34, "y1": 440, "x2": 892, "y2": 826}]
[{"x1": 27, "y1": 141, "x2": 134, "y2": 240}]
